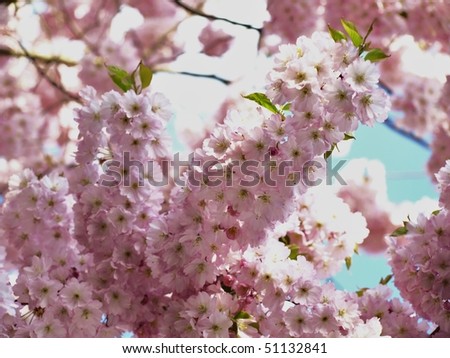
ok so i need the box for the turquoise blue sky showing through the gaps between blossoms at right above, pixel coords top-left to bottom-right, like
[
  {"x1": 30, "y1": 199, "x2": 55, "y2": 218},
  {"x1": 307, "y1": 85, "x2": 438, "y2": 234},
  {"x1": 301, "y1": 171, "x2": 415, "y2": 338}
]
[{"x1": 334, "y1": 119, "x2": 438, "y2": 295}]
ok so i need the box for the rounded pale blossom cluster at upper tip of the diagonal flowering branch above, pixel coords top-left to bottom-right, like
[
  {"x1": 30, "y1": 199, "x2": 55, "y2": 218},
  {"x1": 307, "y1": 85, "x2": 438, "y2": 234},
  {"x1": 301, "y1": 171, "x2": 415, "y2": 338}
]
[{"x1": 267, "y1": 32, "x2": 389, "y2": 133}]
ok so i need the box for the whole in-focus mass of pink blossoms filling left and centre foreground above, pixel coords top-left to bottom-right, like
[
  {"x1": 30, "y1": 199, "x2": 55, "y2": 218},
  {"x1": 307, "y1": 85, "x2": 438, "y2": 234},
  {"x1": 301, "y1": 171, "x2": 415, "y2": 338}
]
[{"x1": 1, "y1": 29, "x2": 394, "y2": 337}]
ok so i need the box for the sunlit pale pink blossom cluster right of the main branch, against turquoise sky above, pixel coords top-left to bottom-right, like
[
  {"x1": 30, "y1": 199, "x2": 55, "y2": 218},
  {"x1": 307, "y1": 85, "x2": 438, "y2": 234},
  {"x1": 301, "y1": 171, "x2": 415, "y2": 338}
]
[{"x1": 276, "y1": 188, "x2": 369, "y2": 278}]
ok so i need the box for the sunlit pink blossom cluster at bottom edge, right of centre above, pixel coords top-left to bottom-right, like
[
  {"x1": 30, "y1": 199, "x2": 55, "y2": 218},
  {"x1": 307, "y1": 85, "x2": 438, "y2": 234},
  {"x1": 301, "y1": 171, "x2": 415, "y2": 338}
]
[{"x1": 231, "y1": 241, "x2": 381, "y2": 337}]
